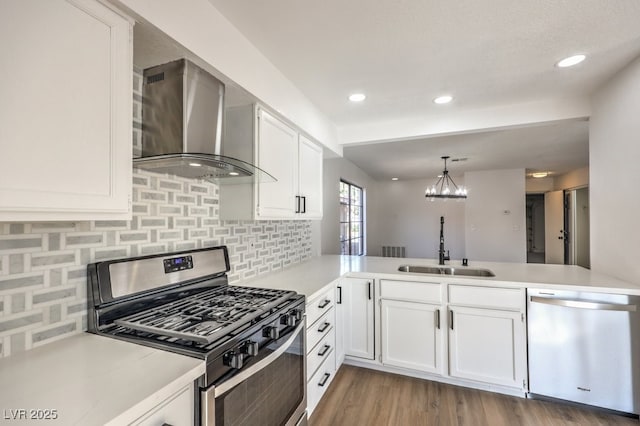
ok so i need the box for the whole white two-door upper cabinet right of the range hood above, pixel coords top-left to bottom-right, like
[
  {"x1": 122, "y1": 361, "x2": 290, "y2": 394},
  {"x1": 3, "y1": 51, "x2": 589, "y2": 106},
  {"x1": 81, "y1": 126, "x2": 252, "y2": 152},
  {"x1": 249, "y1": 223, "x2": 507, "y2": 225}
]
[{"x1": 220, "y1": 105, "x2": 322, "y2": 220}]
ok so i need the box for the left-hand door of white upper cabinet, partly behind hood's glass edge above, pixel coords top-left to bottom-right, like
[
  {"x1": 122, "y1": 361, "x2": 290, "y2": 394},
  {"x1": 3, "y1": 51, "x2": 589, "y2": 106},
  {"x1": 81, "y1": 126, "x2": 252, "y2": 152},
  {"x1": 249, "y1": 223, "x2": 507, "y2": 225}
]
[{"x1": 257, "y1": 109, "x2": 298, "y2": 219}]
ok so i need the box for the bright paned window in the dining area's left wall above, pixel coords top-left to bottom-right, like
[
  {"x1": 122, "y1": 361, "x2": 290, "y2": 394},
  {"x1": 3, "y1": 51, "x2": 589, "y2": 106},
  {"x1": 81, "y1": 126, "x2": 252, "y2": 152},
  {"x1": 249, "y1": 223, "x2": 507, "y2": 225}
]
[{"x1": 340, "y1": 180, "x2": 364, "y2": 256}]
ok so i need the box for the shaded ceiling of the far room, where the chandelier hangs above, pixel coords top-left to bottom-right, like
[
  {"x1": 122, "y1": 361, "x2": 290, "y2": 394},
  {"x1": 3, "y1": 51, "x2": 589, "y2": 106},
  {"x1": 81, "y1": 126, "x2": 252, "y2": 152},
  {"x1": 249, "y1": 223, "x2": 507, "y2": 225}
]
[{"x1": 344, "y1": 120, "x2": 589, "y2": 180}]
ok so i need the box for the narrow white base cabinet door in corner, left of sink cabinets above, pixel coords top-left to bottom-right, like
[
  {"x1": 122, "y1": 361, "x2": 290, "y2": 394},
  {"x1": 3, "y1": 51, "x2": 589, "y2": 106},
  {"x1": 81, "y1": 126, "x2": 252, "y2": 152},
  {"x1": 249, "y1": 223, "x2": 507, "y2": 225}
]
[{"x1": 342, "y1": 278, "x2": 374, "y2": 359}]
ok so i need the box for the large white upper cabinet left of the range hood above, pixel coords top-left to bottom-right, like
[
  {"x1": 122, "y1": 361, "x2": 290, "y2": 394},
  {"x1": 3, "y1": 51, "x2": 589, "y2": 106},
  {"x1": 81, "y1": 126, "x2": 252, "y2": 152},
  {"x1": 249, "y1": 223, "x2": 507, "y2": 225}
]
[{"x1": 0, "y1": 0, "x2": 132, "y2": 221}]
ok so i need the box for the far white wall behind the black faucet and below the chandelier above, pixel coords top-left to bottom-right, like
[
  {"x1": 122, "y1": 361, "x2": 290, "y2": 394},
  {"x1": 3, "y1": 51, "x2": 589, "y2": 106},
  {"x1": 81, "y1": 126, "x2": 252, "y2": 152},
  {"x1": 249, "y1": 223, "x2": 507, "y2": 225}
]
[{"x1": 370, "y1": 176, "x2": 465, "y2": 259}]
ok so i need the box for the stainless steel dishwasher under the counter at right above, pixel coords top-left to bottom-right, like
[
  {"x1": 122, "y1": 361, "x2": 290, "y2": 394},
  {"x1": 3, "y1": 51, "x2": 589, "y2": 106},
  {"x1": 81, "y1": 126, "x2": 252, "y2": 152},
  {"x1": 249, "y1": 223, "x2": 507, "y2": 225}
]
[{"x1": 527, "y1": 289, "x2": 640, "y2": 415}]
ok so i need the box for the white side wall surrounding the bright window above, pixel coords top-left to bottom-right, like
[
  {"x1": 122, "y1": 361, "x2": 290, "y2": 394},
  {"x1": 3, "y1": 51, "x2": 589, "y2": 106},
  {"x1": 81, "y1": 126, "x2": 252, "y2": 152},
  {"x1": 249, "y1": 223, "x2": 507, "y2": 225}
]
[{"x1": 322, "y1": 158, "x2": 379, "y2": 255}]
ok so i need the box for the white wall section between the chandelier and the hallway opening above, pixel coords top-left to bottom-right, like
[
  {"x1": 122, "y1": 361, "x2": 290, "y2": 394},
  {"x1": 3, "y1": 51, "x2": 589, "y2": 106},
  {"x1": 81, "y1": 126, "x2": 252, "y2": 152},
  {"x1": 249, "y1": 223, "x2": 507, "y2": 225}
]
[{"x1": 464, "y1": 169, "x2": 527, "y2": 263}]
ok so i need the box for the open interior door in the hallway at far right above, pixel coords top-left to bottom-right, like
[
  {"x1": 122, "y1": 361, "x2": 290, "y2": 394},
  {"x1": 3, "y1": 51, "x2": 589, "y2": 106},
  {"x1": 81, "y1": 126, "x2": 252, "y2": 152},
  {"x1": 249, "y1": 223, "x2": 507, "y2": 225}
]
[{"x1": 544, "y1": 191, "x2": 565, "y2": 264}]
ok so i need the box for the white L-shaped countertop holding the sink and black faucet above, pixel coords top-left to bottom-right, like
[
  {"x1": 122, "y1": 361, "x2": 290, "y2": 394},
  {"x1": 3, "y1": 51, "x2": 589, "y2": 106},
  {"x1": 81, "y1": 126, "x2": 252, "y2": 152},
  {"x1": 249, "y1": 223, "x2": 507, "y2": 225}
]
[{"x1": 238, "y1": 255, "x2": 640, "y2": 300}]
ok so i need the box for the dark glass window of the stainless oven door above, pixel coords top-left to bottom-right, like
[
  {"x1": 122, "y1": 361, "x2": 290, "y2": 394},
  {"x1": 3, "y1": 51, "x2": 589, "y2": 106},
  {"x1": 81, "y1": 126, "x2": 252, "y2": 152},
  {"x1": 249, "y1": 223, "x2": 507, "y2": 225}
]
[{"x1": 215, "y1": 329, "x2": 305, "y2": 426}]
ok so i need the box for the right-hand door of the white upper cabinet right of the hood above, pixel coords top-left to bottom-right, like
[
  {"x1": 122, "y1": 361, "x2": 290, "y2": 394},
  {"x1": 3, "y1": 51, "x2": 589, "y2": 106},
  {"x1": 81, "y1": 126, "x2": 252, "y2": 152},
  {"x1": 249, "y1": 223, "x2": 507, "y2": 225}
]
[{"x1": 298, "y1": 135, "x2": 322, "y2": 219}]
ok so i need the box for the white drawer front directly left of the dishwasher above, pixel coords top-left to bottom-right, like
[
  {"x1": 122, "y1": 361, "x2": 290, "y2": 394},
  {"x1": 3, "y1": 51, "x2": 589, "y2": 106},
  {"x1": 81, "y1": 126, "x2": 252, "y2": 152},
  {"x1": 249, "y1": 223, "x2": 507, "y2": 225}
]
[{"x1": 449, "y1": 285, "x2": 525, "y2": 311}]
